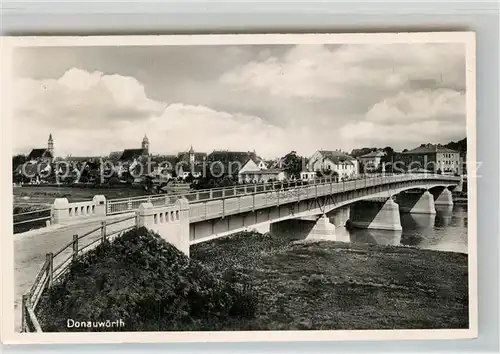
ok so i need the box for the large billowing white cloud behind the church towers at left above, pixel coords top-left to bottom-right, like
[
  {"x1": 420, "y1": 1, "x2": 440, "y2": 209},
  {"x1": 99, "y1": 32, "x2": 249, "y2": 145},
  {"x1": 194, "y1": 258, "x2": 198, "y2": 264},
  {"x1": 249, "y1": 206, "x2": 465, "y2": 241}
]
[{"x1": 14, "y1": 69, "x2": 308, "y2": 156}]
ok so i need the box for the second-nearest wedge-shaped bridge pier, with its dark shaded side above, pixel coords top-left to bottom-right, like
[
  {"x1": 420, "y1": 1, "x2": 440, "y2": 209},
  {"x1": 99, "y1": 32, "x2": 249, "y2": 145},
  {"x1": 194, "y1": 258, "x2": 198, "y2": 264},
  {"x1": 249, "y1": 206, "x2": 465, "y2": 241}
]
[{"x1": 350, "y1": 198, "x2": 403, "y2": 231}]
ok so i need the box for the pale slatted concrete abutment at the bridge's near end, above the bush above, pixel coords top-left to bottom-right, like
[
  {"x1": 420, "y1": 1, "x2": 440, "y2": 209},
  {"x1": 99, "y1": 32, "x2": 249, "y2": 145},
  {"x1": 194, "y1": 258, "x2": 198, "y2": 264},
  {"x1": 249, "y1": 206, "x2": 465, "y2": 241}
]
[{"x1": 136, "y1": 197, "x2": 189, "y2": 256}]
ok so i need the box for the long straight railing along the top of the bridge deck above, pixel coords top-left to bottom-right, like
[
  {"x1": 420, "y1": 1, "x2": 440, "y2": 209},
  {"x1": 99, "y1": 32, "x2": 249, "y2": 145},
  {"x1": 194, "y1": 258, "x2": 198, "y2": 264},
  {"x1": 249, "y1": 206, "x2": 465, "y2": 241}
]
[{"x1": 107, "y1": 173, "x2": 460, "y2": 215}]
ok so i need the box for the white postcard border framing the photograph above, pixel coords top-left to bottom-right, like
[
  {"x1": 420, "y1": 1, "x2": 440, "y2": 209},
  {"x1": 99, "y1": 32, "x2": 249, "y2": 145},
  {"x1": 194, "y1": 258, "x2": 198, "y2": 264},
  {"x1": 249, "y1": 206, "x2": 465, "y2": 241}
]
[{"x1": 0, "y1": 32, "x2": 478, "y2": 344}]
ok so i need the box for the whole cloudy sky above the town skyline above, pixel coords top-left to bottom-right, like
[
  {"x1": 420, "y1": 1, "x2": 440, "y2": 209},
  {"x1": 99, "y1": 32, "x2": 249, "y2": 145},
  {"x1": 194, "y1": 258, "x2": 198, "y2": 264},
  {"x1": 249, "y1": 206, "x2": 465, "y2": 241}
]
[{"x1": 13, "y1": 43, "x2": 466, "y2": 158}]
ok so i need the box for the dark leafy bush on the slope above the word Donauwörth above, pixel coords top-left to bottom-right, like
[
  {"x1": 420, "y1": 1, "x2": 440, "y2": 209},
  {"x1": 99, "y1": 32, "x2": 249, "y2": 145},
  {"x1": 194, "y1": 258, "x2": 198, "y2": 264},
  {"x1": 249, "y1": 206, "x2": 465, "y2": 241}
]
[{"x1": 38, "y1": 228, "x2": 257, "y2": 331}]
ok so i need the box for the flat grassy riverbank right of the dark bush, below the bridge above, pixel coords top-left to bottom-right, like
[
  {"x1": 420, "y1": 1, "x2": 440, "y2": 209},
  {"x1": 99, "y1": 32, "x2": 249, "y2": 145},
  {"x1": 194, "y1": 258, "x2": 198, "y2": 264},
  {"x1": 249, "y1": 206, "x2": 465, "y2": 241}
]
[{"x1": 191, "y1": 232, "x2": 468, "y2": 330}]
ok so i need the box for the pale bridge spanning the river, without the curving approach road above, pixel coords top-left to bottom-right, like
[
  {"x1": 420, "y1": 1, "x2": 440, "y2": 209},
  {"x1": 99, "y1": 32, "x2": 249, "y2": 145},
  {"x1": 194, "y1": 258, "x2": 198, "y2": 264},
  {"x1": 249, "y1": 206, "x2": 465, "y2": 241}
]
[{"x1": 41, "y1": 174, "x2": 462, "y2": 254}]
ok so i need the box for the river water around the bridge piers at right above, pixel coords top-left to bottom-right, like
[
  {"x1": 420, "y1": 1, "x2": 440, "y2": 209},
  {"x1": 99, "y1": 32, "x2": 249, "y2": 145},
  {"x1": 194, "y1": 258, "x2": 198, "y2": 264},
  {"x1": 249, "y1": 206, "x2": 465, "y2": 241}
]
[{"x1": 257, "y1": 204, "x2": 468, "y2": 253}]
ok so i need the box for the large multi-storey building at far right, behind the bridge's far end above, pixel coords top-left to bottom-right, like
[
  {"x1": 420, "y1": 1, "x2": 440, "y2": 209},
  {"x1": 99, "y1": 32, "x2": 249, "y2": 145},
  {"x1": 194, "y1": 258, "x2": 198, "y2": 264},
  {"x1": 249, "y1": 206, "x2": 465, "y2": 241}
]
[{"x1": 400, "y1": 144, "x2": 462, "y2": 174}]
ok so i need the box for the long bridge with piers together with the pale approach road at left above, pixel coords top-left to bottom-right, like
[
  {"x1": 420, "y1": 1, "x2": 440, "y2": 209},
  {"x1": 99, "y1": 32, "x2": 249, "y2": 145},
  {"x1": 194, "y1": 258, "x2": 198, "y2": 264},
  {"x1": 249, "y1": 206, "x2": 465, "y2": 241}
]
[{"x1": 15, "y1": 174, "x2": 463, "y2": 329}]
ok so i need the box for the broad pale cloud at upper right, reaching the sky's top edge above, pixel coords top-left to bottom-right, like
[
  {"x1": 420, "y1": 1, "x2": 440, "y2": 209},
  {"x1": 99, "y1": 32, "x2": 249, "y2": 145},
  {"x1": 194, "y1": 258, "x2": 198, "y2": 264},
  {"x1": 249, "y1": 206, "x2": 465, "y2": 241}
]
[{"x1": 220, "y1": 44, "x2": 465, "y2": 98}]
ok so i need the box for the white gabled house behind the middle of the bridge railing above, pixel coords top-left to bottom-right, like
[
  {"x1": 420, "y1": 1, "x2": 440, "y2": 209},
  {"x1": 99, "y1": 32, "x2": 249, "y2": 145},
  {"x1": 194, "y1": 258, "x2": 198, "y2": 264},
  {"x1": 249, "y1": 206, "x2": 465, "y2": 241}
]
[{"x1": 307, "y1": 150, "x2": 358, "y2": 180}]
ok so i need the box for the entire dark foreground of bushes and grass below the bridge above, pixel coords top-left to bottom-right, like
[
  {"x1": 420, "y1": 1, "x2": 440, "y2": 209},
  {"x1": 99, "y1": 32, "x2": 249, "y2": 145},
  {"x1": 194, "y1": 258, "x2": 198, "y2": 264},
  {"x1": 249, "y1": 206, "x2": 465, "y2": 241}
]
[{"x1": 35, "y1": 228, "x2": 468, "y2": 331}]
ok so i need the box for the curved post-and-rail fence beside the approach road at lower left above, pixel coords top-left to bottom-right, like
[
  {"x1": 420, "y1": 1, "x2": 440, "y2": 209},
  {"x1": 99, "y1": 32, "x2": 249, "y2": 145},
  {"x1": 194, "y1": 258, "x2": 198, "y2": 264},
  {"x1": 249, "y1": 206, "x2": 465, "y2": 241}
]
[{"x1": 21, "y1": 215, "x2": 137, "y2": 332}]
